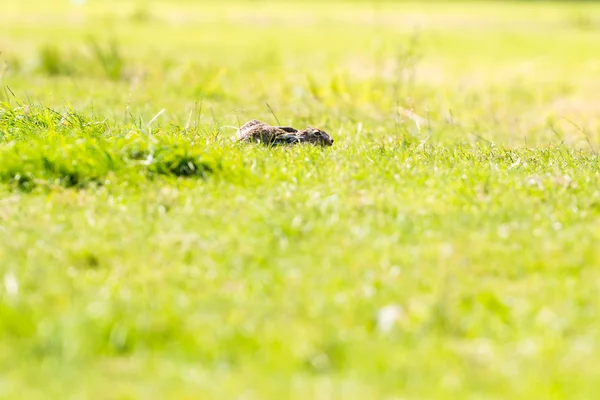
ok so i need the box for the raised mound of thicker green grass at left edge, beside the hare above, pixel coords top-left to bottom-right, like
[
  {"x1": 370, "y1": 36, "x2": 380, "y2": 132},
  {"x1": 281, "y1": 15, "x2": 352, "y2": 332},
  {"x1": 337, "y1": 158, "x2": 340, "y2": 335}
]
[{"x1": 0, "y1": 103, "x2": 221, "y2": 190}]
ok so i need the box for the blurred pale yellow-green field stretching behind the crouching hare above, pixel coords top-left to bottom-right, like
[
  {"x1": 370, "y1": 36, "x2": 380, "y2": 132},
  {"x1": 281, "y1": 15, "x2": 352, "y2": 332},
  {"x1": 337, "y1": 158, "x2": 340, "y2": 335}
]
[{"x1": 0, "y1": 0, "x2": 600, "y2": 146}]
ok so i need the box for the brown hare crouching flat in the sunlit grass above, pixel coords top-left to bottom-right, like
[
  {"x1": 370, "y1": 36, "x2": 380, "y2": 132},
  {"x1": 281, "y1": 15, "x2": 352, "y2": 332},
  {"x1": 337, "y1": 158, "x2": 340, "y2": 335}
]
[{"x1": 234, "y1": 119, "x2": 333, "y2": 146}]
